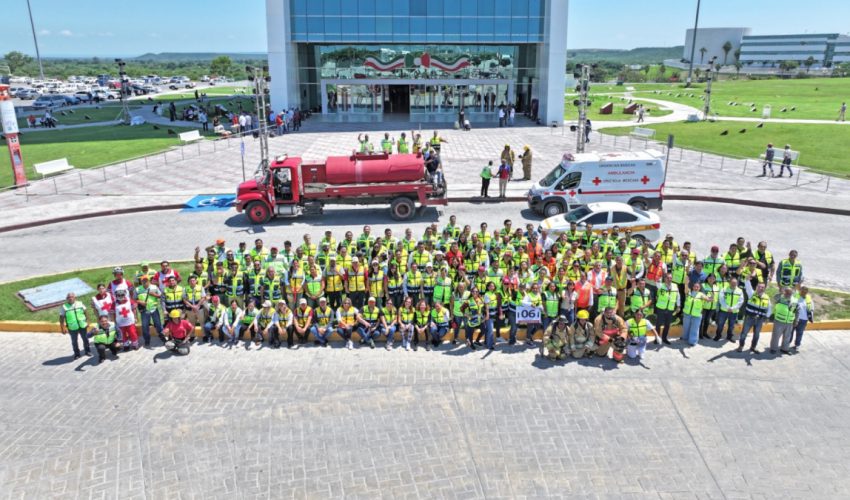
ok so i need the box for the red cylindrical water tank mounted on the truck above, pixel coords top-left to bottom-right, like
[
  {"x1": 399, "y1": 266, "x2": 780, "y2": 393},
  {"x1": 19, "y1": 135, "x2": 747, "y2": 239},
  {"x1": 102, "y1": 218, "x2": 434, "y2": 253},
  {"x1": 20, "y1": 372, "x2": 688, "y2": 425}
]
[{"x1": 325, "y1": 154, "x2": 425, "y2": 185}]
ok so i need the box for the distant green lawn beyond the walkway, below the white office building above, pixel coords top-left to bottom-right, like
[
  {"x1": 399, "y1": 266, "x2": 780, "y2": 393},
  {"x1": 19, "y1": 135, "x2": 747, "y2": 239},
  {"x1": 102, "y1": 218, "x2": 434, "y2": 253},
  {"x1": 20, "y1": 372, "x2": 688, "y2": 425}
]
[{"x1": 628, "y1": 78, "x2": 850, "y2": 120}]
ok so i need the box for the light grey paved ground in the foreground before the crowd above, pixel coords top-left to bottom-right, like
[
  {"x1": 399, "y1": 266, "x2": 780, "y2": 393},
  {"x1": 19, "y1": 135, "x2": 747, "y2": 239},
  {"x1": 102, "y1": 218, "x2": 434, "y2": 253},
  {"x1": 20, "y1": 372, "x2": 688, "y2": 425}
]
[{"x1": 0, "y1": 331, "x2": 850, "y2": 499}]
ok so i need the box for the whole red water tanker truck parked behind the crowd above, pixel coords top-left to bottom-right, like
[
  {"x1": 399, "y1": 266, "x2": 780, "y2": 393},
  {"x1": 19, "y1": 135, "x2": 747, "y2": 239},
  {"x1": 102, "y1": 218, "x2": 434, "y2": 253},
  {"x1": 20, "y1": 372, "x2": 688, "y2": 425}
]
[{"x1": 236, "y1": 154, "x2": 446, "y2": 224}]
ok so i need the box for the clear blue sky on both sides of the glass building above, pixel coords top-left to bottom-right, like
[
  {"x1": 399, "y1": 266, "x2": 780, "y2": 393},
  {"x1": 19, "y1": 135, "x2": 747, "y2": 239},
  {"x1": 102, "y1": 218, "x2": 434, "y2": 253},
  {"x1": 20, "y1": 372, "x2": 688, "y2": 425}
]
[{"x1": 0, "y1": 0, "x2": 850, "y2": 57}]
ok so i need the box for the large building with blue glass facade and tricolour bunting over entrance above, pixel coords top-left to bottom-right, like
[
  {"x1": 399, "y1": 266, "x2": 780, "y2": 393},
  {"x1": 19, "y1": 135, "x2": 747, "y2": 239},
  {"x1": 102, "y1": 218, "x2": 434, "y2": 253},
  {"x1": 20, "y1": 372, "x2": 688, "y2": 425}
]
[{"x1": 267, "y1": 0, "x2": 566, "y2": 123}]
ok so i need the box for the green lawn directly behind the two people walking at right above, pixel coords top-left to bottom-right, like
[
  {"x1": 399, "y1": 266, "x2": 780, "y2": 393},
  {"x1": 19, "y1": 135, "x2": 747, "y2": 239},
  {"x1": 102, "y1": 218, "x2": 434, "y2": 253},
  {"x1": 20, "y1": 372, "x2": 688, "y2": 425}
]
[{"x1": 604, "y1": 122, "x2": 850, "y2": 177}]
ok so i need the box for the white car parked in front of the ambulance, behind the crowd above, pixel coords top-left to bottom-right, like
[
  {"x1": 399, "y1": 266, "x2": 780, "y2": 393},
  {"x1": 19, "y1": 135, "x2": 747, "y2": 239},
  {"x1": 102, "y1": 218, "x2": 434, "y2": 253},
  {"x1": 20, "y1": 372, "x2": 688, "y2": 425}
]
[{"x1": 540, "y1": 202, "x2": 661, "y2": 242}]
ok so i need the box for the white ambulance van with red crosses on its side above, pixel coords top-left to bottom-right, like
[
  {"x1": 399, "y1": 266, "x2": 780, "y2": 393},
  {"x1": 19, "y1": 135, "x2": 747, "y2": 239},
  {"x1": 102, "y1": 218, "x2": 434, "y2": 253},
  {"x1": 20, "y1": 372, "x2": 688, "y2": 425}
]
[{"x1": 528, "y1": 150, "x2": 664, "y2": 217}]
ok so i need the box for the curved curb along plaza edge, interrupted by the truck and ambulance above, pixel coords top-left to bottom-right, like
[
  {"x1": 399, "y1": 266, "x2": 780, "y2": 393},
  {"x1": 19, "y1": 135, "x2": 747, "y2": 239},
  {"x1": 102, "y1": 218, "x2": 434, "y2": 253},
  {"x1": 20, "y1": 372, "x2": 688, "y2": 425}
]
[{"x1": 0, "y1": 194, "x2": 850, "y2": 233}]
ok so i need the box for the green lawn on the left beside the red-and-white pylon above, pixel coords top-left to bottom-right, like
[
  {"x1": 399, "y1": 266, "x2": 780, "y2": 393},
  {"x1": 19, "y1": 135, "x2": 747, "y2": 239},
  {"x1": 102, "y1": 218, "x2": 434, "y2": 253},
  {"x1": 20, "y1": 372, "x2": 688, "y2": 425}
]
[{"x1": 0, "y1": 124, "x2": 213, "y2": 187}]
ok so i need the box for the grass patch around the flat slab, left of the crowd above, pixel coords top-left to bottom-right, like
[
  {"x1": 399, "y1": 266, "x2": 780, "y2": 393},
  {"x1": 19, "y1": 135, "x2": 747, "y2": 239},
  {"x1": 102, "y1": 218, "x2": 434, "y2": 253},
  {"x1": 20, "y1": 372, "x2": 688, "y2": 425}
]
[{"x1": 0, "y1": 262, "x2": 192, "y2": 322}]
